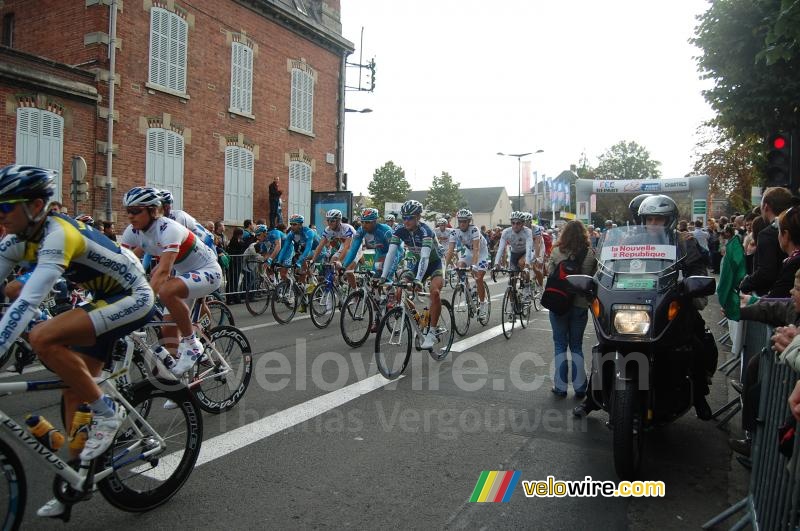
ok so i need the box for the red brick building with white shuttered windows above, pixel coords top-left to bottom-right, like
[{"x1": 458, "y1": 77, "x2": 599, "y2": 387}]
[{"x1": 0, "y1": 0, "x2": 353, "y2": 225}]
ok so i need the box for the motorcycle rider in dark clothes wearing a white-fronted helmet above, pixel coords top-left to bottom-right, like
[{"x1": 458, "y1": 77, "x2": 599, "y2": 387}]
[{"x1": 572, "y1": 195, "x2": 717, "y2": 420}]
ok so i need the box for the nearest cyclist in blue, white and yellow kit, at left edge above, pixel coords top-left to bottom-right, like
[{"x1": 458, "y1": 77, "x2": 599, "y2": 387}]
[{"x1": 0, "y1": 165, "x2": 155, "y2": 516}]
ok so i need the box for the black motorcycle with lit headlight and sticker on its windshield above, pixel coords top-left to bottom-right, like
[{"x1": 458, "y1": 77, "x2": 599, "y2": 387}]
[{"x1": 567, "y1": 225, "x2": 716, "y2": 480}]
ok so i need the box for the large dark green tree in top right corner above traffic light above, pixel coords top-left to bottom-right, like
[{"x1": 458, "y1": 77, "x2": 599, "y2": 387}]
[{"x1": 692, "y1": 0, "x2": 800, "y2": 137}]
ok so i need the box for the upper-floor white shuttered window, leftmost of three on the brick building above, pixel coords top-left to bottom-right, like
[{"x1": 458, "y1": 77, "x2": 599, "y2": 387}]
[{"x1": 149, "y1": 7, "x2": 188, "y2": 94}]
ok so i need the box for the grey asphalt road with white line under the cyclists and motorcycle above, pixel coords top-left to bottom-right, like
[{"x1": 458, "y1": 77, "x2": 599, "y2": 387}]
[{"x1": 0, "y1": 283, "x2": 730, "y2": 530}]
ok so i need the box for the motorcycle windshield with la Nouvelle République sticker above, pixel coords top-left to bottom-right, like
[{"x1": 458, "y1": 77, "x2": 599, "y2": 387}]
[{"x1": 597, "y1": 225, "x2": 677, "y2": 289}]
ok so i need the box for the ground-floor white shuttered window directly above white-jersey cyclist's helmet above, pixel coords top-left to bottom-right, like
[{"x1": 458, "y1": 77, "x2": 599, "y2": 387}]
[{"x1": 145, "y1": 128, "x2": 183, "y2": 210}]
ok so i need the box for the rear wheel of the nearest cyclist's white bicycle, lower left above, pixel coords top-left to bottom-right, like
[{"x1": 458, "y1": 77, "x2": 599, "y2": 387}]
[{"x1": 97, "y1": 380, "x2": 203, "y2": 512}]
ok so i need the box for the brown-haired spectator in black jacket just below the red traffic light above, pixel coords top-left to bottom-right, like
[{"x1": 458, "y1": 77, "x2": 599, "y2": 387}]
[{"x1": 737, "y1": 187, "x2": 792, "y2": 295}]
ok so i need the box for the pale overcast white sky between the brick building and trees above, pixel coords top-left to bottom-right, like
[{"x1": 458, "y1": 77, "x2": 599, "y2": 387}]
[{"x1": 341, "y1": 0, "x2": 714, "y2": 200}]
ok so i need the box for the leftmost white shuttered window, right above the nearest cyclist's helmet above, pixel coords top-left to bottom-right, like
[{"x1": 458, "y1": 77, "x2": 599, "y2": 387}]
[{"x1": 16, "y1": 107, "x2": 64, "y2": 201}]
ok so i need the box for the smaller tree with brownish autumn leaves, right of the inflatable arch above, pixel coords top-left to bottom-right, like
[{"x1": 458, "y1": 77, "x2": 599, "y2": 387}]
[{"x1": 694, "y1": 126, "x2": 763, "y2": 211}]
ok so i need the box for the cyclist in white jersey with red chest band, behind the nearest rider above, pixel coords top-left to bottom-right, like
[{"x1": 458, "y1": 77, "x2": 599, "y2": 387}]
[{"x1": 120, "y1": 186, "x2": 222, "y2": 376}]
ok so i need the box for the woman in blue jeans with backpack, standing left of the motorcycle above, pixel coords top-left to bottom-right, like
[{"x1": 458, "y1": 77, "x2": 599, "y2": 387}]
[{"x1": 547, "y1": 220, "x2": 597, "y2": 399}]
